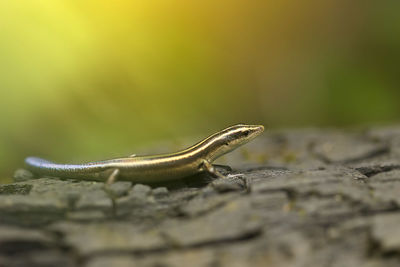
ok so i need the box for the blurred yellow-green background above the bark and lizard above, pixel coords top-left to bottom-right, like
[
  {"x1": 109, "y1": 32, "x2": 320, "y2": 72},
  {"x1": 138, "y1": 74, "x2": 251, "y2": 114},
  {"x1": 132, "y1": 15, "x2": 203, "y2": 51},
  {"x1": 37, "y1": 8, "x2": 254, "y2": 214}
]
[{"x1": 0, "y1": 0, "x2": 400, "y2": 182}]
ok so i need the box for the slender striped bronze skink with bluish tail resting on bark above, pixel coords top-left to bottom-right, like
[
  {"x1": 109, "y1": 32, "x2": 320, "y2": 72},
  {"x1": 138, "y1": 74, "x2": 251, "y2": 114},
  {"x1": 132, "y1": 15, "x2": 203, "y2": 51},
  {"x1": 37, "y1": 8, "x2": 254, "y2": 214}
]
[{"x1": 25, "y1": 124, "x2": 264, "y2": 183}]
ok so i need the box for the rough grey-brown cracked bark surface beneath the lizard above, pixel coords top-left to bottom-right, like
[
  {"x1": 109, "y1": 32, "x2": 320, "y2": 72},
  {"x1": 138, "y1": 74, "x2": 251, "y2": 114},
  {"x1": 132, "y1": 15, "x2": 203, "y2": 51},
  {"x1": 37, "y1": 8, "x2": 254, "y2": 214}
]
[{"x1": 0, "y1": 127, "x2": 400, "y2": 267}]
